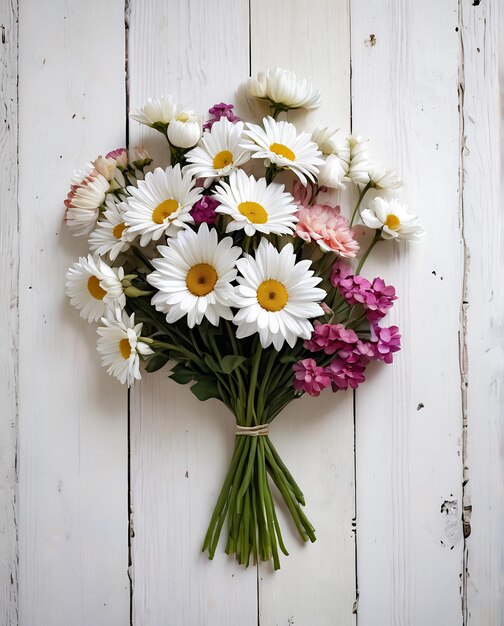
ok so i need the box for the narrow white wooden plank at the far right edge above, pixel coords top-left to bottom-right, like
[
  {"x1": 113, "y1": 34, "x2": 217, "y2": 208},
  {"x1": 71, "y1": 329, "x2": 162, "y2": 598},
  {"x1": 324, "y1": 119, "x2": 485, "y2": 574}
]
[{"x1": 459, "y1": 0, "x2": 504, "y2": 626}]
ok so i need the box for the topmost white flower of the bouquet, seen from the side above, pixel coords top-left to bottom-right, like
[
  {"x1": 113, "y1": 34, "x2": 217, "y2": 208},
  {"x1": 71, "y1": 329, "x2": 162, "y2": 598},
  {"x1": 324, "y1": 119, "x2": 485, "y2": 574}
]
[{"x1": 247, "y1": 67, "x2": 320, "y2": 111}]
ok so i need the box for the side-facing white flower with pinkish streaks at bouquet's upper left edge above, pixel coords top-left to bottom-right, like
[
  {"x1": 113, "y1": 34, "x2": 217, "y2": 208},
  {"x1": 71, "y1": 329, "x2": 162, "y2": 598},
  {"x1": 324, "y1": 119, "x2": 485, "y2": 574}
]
[{"x1": 65, "y1": 163, "x2": 110, "y2": 236}]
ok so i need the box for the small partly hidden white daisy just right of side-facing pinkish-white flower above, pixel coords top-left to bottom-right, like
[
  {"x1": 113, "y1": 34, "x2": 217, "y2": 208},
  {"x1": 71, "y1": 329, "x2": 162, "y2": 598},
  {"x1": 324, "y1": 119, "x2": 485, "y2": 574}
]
[{"x1": 89, "y1": 199, "x2": 134, "y2": 261}]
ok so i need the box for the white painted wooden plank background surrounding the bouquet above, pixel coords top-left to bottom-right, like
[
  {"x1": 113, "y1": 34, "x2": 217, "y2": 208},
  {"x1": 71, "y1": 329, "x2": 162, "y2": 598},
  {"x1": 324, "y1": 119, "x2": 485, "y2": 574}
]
[{"x1": 0, "y1": 0, "x2": 504, "y2": 626}]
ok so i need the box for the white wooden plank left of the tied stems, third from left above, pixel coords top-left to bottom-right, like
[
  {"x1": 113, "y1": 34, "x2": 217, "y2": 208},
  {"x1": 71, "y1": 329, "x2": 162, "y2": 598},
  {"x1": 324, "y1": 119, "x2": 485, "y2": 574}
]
[{"x1": 129, "y1": 0, "x2": 257, "y2": 626}]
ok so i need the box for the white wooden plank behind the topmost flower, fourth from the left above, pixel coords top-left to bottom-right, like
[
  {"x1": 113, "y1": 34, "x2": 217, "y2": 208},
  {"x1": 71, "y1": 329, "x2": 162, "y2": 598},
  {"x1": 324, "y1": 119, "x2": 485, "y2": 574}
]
[{"x1": 251, "y1": 0, "x2": 356, "y2": 626}]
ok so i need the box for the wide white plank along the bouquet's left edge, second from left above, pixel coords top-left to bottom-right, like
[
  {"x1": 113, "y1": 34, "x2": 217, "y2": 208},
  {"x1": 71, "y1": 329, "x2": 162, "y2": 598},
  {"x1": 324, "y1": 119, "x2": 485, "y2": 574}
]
[{"x1": 19, "y1": 0, "x2": 129, "y2": 626}]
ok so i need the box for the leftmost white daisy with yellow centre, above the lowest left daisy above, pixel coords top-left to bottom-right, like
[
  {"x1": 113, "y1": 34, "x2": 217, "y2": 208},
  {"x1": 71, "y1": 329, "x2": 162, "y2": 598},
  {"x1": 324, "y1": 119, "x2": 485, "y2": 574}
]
[{"x1": 66, "y1": 254, "x2": 126, "y2": 322}]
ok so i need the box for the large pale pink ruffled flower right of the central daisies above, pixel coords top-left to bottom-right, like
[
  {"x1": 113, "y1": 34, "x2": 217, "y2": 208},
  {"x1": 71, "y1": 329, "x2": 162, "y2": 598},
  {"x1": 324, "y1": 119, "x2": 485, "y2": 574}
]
[{"x1": 296, "y1": 204, "x2": 359, "y2": 258}]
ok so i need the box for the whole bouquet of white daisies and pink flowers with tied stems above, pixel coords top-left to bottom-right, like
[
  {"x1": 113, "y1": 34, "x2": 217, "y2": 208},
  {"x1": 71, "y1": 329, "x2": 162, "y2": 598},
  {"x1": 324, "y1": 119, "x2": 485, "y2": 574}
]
[{"x1": 65, "y1": 68, "x2": 421, "y2": 569}]
